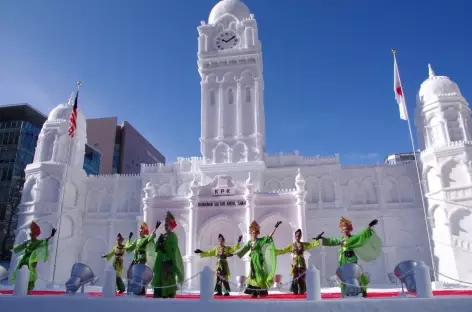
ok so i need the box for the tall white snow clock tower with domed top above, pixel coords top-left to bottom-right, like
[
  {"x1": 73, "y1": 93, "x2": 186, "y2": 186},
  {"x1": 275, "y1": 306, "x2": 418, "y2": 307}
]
[{"x1": 198, "y1": 0, "x2": 265, "y2": 164}]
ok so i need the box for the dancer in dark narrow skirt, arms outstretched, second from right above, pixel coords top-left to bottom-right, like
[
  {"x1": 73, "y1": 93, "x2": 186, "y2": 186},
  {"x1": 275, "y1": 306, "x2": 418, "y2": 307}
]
[{"x1": 275, "y1": 229, "x2": 320, "y2": 295}]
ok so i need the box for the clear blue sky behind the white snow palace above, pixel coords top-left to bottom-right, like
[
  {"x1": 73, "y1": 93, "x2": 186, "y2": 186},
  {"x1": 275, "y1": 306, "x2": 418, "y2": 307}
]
[{"x1": 0, "y1": 0, "x2": 472, "y2": 163}]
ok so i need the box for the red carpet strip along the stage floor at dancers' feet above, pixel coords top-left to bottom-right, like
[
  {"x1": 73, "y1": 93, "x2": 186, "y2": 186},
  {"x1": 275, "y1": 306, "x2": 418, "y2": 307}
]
[{"x1": 0, "y1": 289, "x2": 472, "y2": 300}]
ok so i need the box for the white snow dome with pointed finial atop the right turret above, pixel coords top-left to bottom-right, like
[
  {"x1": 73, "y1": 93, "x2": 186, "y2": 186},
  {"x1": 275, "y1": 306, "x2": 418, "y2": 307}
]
[{"x1": 418, "y1": 64, "x2": 462, "y2": 103}]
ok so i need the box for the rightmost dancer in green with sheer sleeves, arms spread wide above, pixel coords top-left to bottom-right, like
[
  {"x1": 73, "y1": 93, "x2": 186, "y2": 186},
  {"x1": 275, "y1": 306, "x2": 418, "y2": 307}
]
[{"x1": 314, "y1": 217, "x2": 381, "y2": 297}]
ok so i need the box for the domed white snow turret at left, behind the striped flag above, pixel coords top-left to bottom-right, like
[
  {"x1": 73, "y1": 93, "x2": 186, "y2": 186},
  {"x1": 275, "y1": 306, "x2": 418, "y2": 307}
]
[{"x1": 12, "y1": 93, "x2": 87, "y2": 286}]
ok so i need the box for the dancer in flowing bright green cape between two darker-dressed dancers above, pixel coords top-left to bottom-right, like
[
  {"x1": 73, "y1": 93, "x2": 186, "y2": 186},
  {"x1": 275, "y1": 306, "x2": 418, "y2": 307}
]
[{"x1": 237, "y1": 221, "x2": 282, "y2": 298}]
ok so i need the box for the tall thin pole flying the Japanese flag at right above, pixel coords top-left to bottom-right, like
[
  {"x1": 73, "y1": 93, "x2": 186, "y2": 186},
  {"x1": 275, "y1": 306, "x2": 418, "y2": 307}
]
[{"x1": 392, "y1": 49, "x2": 438, "y2": 281}]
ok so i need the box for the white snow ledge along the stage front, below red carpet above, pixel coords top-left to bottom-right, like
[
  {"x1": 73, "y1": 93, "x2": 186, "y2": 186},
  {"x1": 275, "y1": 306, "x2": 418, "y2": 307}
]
[{"x1": 0, "y1": 295, "x2": 472, "y2": 312}]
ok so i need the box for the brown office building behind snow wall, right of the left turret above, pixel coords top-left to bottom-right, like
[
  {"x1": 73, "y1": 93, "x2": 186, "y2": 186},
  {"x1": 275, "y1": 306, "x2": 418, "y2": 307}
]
[{"x1": 87, "y1": 117, "x2": 166, "y2": 174}]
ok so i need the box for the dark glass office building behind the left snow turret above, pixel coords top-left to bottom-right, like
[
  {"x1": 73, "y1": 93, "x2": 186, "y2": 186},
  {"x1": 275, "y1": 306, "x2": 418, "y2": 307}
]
[{"x1": 0, "y1": 104, "x2": 101, "y2": 261}]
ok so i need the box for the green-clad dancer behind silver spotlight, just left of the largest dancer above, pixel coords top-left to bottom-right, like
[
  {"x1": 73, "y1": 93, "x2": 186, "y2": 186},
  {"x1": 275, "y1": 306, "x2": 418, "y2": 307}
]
[{"x1": 125, "y1": 221, "x2": 161, "y2": 296}]
